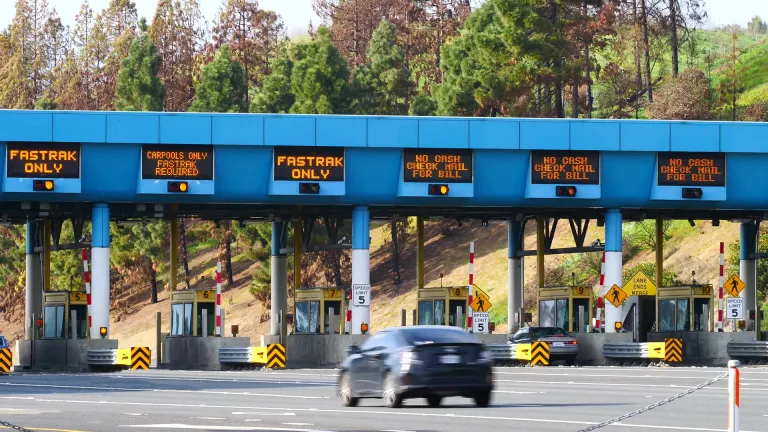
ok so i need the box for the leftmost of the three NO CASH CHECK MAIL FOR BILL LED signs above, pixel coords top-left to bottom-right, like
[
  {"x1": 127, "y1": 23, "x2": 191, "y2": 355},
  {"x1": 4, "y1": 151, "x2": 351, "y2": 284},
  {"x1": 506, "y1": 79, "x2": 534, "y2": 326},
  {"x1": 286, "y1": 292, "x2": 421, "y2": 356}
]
[{"x1": 403, "y1": 149, "x2": 473, "y2": 183}]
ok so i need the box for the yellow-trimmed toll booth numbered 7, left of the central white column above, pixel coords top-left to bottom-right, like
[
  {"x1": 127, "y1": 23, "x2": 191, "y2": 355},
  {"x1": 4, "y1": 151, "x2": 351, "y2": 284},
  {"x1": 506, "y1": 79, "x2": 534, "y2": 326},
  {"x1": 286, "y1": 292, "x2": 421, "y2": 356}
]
[{"x1": 294, "y1": 287, "x2": 347, "y2": 334}]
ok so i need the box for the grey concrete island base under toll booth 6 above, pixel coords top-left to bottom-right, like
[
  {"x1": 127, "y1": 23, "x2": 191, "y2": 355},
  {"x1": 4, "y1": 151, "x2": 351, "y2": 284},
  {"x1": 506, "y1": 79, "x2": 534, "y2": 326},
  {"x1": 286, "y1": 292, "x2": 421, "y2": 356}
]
[{"x1": 162, "y1": 336, "x2": 251, "y2": 371}]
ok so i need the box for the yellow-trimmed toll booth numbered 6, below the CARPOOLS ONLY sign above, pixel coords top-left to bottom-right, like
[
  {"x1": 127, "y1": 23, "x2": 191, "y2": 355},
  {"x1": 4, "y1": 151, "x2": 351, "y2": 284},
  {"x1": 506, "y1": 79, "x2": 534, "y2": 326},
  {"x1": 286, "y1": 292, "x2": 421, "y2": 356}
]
[{"x1": 171, "y1": 289, "x2": 216, "y2": 337}]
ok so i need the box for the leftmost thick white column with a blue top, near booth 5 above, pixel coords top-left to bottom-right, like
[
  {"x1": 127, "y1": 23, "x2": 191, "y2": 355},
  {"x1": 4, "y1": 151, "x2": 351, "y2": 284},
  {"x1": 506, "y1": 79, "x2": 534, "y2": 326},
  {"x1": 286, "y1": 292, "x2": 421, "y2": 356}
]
[{"x1": 91, "y1": 203, "x2": 110, "y2": 339}]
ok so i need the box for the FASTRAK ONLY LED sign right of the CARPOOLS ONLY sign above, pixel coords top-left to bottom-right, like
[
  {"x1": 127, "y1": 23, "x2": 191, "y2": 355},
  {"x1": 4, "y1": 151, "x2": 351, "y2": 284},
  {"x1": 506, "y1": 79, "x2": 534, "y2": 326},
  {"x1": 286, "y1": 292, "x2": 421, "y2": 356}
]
[{"x1": 273, "y1": 147, "x2": 345, "y2": 182}]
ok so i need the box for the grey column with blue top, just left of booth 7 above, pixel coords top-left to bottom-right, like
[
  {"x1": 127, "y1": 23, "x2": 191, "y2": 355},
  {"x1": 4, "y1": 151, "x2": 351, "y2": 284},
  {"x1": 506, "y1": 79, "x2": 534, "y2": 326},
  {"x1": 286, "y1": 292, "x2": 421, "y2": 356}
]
[{"x1": 270, "y1": 222, "x2": 288, "y2": 336}]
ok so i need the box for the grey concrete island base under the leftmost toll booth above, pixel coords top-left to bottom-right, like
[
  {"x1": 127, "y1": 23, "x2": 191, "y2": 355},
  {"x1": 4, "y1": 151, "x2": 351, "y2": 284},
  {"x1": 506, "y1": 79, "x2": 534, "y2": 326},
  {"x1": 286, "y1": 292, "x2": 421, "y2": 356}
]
[{"x1": 14, "y1": 339, "x2": 117, "y2": 372}]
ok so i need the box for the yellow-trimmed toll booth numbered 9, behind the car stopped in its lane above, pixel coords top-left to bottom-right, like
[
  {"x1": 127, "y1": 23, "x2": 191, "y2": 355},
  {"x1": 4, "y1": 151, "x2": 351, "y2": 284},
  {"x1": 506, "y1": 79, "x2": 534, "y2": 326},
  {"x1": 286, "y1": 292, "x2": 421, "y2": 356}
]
[{"x1": 539, "y1": 285, "x2": 593, "y2": 333}]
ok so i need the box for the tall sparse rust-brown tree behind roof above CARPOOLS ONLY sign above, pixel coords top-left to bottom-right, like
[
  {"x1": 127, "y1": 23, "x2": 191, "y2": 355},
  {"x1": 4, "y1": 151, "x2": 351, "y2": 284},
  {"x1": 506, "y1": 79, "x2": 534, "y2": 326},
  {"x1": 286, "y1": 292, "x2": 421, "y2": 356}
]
[{"x1": 149, "y1": 0, "x2": 205, "y2": 111}]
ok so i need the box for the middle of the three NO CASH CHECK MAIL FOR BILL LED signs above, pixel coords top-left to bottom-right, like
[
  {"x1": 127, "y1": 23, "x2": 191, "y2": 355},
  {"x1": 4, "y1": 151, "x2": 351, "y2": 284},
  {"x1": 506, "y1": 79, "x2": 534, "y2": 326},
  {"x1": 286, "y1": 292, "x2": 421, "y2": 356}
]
[{"x1": 531, "y1": 151, "x2": 600, "y2": 185}]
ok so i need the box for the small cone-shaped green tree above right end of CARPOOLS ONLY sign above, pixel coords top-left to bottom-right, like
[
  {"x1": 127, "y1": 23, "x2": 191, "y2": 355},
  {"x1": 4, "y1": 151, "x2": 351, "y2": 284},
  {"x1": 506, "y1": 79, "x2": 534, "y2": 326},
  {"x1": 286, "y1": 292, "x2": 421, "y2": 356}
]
[{"x1": 189, "y1": 45, "x2": 248, "y2": 113}]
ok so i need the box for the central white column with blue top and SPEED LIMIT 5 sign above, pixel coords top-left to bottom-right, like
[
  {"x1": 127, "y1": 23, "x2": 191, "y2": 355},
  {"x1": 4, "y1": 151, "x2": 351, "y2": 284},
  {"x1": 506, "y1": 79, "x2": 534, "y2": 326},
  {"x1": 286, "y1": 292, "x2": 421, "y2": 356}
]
[{"x1": 350, "y1": 206, "x2": 371, "y2": 334}]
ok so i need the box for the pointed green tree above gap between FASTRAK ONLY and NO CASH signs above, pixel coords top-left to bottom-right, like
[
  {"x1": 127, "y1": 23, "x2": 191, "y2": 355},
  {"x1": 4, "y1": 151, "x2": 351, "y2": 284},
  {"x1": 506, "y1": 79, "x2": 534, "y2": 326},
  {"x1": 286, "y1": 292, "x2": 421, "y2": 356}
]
[{"x1": 356, "y1": 21, "x2": 413, "y2": 115}]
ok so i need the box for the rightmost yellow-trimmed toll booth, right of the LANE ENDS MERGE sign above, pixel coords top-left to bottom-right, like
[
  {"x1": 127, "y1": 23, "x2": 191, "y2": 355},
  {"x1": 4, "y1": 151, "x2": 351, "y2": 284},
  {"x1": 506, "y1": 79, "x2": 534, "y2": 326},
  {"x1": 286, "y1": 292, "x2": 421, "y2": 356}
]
[{"x1": 656, "y1": 285, "x2": 714, "y2": 332}]
